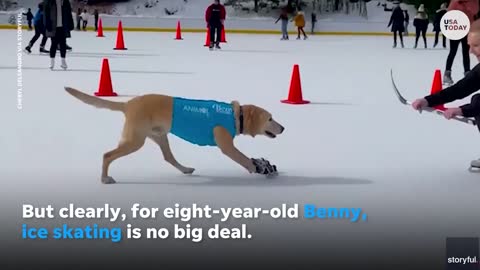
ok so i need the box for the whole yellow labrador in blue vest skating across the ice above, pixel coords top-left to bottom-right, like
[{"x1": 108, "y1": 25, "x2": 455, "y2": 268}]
[{"x1": 65, "y1": 87, "x2": 285, "y2": 184}]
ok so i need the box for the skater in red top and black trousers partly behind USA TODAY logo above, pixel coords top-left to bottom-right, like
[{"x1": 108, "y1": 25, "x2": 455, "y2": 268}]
[{"x1": 443, "y1": 0, "x2": 479, "y2": 85}]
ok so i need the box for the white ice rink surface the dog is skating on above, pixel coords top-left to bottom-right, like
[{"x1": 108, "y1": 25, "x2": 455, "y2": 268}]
[{"x1": 0, "y1": 30, "x2": 480, "y2": 264}]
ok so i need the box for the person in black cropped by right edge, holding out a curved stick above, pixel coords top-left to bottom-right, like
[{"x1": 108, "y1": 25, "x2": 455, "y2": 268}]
[{"x1": 412, "y1": 21, "x2": 480, "y2": 168}]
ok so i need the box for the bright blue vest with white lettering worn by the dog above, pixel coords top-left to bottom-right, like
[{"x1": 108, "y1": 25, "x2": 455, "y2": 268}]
[{"x1": 170, "y1": 97, "x2": 236, "y2": 146}]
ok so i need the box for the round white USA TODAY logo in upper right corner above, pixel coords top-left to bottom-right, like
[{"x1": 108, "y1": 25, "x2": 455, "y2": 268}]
[{"x1": 440, "y1": 10, "x2": 470, "y2": 40}]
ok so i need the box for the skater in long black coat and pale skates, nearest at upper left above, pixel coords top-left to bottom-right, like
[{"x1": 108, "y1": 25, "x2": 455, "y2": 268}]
[{"x1": 43, "y1": 0, "x2": 74, "y2": 69}]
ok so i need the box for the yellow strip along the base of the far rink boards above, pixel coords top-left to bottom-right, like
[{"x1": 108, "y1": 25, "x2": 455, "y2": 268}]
[{"x1": 0, "y1": 24, "x2": 434, "y2": 37}]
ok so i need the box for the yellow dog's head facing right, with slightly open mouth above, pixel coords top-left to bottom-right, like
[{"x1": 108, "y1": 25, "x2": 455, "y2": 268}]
[{"x1": 236, "y1": 102, "x2": 285, "y2": 138}]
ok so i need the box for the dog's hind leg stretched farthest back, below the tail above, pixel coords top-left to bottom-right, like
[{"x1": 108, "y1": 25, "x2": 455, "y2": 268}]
[{"x1": 102, "y1": 135, "x2": 146, "y2": 184}]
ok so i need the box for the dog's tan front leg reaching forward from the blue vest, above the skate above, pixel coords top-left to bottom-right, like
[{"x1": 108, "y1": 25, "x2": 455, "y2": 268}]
[{"x1": 213, "y1": 127, "x2": 256, "y2": 173}]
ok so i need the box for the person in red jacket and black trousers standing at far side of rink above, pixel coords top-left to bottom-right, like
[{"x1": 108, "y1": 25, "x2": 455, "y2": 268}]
[{"x1": 205, "y1": 0, "x2": 226, "y2": 49}]
